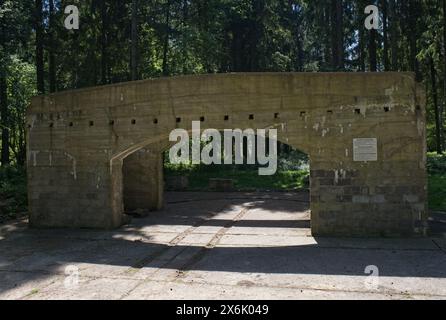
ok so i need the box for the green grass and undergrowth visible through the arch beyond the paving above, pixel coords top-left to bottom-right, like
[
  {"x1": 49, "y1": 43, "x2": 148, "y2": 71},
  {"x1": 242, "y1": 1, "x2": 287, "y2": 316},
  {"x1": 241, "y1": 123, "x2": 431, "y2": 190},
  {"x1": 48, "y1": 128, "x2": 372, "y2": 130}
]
[{"x1": 163, "y1": 142, "x2": 310, "y2": 192}]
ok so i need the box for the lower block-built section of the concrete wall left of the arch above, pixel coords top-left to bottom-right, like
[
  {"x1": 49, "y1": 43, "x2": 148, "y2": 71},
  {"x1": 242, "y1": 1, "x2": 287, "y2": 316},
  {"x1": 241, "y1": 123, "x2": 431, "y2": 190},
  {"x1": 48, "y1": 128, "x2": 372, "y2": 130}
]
[{"x1": 27, "y1": 158, "x2": 128, "y2": 229}]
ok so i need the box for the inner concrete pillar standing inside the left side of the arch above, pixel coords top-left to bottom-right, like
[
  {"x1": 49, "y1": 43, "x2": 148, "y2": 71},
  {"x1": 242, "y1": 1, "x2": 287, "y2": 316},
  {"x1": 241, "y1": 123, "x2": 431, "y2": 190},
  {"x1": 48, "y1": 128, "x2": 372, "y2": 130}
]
[{"x1": 122, "y1": 149, "x2": 164, "y2": 212}]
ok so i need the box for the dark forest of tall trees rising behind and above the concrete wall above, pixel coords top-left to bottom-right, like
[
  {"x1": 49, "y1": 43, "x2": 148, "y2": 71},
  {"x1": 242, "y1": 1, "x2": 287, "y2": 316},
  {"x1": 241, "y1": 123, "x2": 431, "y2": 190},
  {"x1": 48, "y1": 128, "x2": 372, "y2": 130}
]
[{"x1": 0, "y1": 0, "x2": 446, "y2": 166}]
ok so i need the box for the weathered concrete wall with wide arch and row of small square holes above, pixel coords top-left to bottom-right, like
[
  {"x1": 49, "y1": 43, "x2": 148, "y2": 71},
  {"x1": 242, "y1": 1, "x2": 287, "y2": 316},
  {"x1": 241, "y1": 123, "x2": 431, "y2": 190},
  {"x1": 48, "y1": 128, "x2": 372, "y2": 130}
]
[{"x1": 27, "y1": 73, "x2": 427, "y2": 236}]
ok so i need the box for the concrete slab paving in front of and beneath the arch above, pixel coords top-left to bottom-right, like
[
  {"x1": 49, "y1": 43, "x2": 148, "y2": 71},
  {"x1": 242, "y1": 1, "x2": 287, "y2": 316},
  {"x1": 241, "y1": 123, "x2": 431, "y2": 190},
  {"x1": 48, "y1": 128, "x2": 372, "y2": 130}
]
[{"x1": 0, "y1": 193, "x2": 446, "y2": 300}]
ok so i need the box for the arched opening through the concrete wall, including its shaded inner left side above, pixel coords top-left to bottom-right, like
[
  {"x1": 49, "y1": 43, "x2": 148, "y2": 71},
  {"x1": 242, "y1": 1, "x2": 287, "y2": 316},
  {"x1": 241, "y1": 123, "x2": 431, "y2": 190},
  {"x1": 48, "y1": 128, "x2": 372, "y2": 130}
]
[{"x1": 122, "y1": 132, "x2": 311, "y2": 235}]
